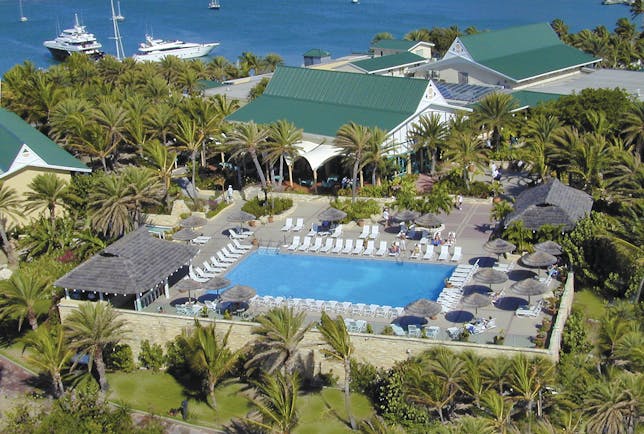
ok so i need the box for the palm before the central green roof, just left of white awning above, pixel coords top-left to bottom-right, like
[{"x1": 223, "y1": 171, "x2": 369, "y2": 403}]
[{"x1": 267, "y1": 119, "x2": 302, "y2": 185}]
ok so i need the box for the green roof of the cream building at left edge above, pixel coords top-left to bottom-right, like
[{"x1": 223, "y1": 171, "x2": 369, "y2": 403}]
[{"x1": 0, "y1": 108, "x2": 90, "y2": 174}]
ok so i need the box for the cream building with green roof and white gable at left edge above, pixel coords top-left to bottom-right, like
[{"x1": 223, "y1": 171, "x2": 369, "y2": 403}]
[{"x1": 0, "y1": 108, "x2": 91, "y2": 224}]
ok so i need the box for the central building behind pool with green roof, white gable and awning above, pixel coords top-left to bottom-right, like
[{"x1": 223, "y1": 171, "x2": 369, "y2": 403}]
[{"x1": 228, "y1": 67, "x2": 459, "y2": 181}]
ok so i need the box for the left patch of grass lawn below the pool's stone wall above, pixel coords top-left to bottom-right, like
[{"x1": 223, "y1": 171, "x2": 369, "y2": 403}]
[{"x1": 108, "y1": 371, "x2": 250, "y2": 427}]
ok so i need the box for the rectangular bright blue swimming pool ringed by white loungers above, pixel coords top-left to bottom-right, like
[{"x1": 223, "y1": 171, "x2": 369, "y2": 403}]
[{"x1": 221, "y1": 252, "x2": 454, "y2": 306}]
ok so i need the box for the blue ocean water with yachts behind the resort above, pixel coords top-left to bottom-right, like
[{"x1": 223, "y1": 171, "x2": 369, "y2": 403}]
[{"x1": 0, "y1": 0, "x2": 629, "y2": 73}]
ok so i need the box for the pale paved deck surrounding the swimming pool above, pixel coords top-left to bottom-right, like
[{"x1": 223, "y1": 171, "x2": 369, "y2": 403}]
[{"x1": 145, "y1": 194, "x2": 558, "y2": 347}]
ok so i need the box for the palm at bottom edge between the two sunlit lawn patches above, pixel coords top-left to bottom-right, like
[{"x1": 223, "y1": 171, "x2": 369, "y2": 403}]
[{"x1": 248, "y1": 372, "x2": 300, "y2": 434}]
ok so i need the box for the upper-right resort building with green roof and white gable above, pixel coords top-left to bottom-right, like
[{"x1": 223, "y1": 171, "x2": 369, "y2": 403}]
[{"x1": 413, "y1": 23, "x2": 601, "y2": 89}]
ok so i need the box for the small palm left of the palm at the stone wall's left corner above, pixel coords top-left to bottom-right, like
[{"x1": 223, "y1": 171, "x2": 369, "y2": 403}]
[{"x1": 22, "y1": 325, "x2": 74, "y2": 398}]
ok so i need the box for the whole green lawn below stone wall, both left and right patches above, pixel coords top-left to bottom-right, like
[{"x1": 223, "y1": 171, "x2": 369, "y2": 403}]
[{"x1": 108, "y1": 371, "x2": 373, "y2": 433}]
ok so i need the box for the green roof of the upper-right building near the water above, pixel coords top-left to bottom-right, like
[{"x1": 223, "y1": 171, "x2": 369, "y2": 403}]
[{"x1": 460, "y1": 23, "x2": 600, "y2": 81}]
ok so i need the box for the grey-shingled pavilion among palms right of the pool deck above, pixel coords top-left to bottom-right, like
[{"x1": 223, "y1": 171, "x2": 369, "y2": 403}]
[{"x1": 505, "y1": 179, "x2": 593, "y2": 231}]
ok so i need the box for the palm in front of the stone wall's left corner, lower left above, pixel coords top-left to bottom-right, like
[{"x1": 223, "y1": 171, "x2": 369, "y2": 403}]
[{"x1": 64, "y1": 302, "x2": 128, "y2": 392}]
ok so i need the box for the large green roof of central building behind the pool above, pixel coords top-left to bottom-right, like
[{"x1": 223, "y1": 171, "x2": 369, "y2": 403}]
[{"x1": 228, "y1": 66, "x2": 428, "y2": 137}]
